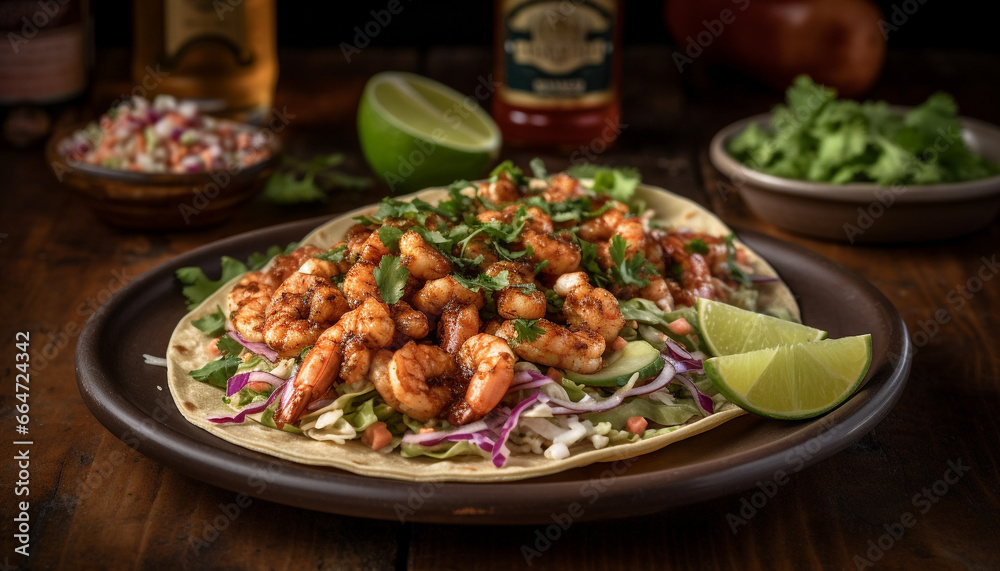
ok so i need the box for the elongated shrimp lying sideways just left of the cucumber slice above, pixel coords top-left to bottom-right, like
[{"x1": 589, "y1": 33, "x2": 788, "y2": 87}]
[{"x1": 496, "y1": 319, "x2": 605, "y2": 373}]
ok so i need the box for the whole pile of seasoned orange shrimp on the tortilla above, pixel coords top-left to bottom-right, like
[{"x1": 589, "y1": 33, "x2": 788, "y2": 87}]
[{"x1": 228, "y1": 173, "x2": 748, "y2": 434}]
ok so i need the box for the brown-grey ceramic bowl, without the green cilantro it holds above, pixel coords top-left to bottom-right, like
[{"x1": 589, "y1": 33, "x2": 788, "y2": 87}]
[{"x1": 709, "y1": 108, "x2": 1000, "y2": 244}]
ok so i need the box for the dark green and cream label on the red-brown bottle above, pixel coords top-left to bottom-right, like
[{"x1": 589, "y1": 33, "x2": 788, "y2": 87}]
[{"x1": 501, "y1": 0, "x2": 617, "y2": 108}]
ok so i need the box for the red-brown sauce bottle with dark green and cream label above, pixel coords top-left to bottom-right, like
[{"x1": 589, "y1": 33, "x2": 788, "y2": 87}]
[{"x1": 493, "y1": 0, "x2": 623, "y2": 152}]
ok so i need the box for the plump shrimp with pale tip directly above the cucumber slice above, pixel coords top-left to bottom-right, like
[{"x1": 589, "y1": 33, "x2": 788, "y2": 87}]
[{"x1": 552, "y1": 272, "x2": 625, "y2": 343}]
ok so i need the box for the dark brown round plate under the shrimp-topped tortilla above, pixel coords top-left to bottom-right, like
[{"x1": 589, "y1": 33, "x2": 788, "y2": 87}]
[{"x1": 76, "y1": 219, "x2": 912, "y2": 524}]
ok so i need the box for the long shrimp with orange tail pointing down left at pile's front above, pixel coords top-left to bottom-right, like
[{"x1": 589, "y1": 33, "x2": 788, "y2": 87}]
[{"x1": 274, "y1": 299, "x2": 398, "y2": 428}]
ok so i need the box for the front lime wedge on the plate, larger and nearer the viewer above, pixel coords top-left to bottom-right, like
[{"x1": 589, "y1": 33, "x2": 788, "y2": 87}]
[{"x1": 705, "y1": 335, "x2": 872, "y2": 419}]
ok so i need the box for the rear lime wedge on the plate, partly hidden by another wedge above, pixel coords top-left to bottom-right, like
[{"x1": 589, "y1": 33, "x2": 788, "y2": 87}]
[{"x1": 696, "y1": 298, "x2": 826, "y2": 357}]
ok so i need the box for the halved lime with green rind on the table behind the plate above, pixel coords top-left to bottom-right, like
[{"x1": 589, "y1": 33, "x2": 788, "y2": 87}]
[{"x1": 358, "y1": 71, "x2": 501, "y2": 193}]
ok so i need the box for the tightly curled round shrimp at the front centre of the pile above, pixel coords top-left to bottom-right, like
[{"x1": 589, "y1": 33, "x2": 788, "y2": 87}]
[{"x1": 370, "y1": 341, "x2": 458, "y2": 421}]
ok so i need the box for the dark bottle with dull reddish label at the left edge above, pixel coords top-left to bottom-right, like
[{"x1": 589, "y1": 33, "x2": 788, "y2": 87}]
[{"x1": 0, "y1": 0, "x2": 93, "y2": 147}]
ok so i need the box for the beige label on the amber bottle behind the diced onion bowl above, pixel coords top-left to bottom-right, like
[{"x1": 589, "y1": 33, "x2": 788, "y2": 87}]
[{"x1": 163, "y1": 0, "x2": 253, "y2": 65}]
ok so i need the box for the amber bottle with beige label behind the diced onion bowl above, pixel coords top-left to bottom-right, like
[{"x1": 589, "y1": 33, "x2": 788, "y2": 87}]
[{"x1": 132, "y1": 0, "x2": 278, "y2": 124}]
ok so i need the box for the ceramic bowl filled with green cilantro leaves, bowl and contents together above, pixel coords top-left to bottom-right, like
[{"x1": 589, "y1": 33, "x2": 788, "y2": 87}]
[{"x1": 709, "y1": 77, "x2": 1000, "y2": 244}]
